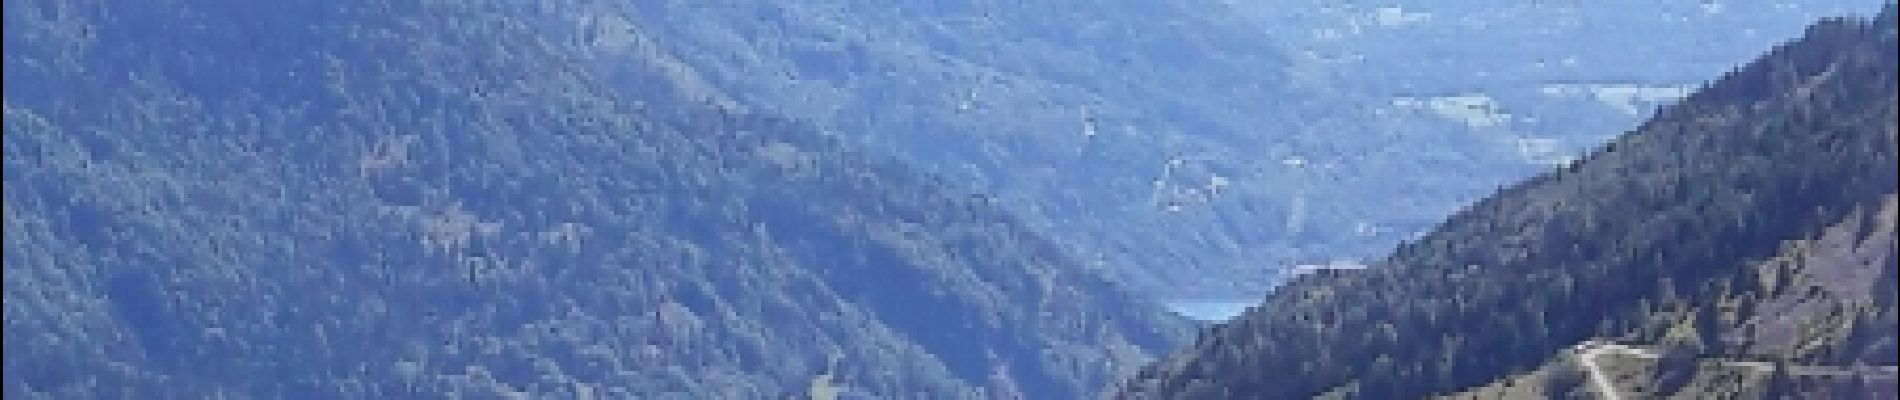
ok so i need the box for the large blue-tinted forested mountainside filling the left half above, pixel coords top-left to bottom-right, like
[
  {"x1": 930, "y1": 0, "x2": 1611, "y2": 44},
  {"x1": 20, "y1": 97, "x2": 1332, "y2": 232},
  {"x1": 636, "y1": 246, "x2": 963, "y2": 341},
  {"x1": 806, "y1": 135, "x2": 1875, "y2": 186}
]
[{"x1": 4, "y1": 0, "x2": 1186, "y2": 398}]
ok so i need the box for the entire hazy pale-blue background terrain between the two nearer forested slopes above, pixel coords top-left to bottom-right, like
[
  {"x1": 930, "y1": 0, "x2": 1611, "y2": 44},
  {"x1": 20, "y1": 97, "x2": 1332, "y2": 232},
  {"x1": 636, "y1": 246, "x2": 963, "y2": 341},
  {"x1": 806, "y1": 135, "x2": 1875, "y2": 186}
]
[{"x1": 578, "y1": 0, "x2": 1873, "y2": 298}]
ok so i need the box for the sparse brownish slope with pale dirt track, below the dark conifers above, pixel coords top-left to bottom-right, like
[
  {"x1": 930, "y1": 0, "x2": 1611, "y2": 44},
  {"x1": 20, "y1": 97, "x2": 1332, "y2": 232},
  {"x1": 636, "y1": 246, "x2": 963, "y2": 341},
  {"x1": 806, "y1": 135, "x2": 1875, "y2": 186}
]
[{"x1": 1446, "y1": 195, "x2": 1900, "y2": 400}]
